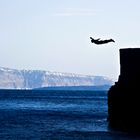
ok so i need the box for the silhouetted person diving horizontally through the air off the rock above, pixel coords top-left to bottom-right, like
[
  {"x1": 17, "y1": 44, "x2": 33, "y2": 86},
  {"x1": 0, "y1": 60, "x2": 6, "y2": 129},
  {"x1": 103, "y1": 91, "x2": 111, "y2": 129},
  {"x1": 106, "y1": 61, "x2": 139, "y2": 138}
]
[{"x1": 90, "y1": 37, "x2": 115, "y2": 45}]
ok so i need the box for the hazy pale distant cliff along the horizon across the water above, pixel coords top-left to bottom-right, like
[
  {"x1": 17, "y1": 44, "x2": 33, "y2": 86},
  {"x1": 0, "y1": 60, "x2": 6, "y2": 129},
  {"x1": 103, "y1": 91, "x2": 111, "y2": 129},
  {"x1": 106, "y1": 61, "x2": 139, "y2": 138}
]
[{"x1": 0, "y1": 67, "x2": 113, "y2": 89}]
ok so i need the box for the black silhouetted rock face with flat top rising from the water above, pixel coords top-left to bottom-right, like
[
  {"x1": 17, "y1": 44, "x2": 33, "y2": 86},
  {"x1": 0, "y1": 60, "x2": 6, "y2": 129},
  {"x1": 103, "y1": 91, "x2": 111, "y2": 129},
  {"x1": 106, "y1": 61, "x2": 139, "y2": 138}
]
[{"x1": 108, "y1": 48, "x2": 140, "y2": 133}]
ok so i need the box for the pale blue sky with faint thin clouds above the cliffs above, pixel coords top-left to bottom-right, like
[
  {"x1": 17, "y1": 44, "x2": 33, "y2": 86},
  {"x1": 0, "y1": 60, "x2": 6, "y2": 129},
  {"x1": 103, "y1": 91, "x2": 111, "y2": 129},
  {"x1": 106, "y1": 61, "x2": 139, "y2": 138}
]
[{"x1": 0, "y1": 0, "x2": 140, "y2": 80}]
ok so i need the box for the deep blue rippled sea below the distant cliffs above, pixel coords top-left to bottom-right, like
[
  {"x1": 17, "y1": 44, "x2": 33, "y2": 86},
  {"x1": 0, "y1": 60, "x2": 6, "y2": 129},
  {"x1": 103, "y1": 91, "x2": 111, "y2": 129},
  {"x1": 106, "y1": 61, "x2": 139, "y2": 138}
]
[{"x1": 0, "y1": 90, "x2": 140, "y2": 140}]
